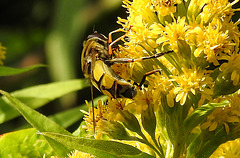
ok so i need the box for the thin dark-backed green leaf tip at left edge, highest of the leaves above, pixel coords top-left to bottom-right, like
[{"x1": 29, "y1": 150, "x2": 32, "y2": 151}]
[{"x1": 0, "y1": 64, "x2": 46, "y2": 76}]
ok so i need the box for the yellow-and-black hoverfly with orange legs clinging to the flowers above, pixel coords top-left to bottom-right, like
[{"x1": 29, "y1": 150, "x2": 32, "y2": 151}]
[{"x1": 81, "y1": 29, "x2": 173, "y2": 131}]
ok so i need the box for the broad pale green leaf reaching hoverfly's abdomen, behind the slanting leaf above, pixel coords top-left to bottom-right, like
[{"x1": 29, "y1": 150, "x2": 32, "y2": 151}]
[{"x1": 0, "y1": 79, "x2": 88, "y2": 124}]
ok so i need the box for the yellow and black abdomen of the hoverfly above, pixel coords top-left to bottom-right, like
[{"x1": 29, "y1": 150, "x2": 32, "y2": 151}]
[{"x1": 92, "y1": 60, "x2": 136, "y2": 98}]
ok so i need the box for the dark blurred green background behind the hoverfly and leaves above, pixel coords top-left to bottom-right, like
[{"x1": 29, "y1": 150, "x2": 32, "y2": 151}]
[{"x1": 0, "y1": 0, "x2": 127, "y2": 134}]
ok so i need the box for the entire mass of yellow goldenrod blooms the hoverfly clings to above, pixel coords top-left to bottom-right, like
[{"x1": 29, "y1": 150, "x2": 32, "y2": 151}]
[{"x1": 82, "y1": 0, "x2": 240, "y2": 155}]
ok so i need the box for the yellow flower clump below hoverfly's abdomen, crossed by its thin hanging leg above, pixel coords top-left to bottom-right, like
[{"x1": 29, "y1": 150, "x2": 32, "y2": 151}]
[{"x1": 82, "y1": 98, "x2": 135, "y2": 139}]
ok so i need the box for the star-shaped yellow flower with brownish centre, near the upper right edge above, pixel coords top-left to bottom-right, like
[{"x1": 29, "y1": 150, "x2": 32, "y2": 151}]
[{"x1": 191, "y1": 19, "x2": 235, "y2": 66}]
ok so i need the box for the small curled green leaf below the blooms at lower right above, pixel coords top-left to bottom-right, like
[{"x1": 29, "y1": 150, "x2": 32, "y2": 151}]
[{"x1": 183, "y1": 101, "x2": 229, "y2": 134}]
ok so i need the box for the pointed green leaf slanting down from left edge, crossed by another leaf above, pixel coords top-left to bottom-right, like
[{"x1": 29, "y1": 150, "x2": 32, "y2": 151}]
[{"x1": 0, "y1": 90, "x2": 71, "y2": 156}]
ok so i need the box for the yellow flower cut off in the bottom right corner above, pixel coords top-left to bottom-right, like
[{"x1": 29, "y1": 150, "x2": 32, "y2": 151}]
[{"x1": 210, "y1": 139, "x2": 240, "y2": 158}]
